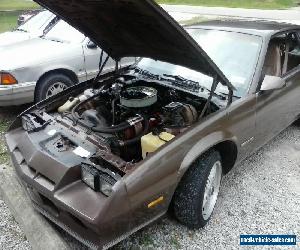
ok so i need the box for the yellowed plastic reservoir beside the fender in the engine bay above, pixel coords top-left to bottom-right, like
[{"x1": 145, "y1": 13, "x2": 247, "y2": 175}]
[{"x1": 141, "y1": 132, "x2": 175, "y2": 159}]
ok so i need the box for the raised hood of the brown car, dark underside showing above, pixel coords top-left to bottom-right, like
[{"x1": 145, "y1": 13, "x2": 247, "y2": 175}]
[{"x1": 35, "y1": 0, "x2": 234, "y2": 90}]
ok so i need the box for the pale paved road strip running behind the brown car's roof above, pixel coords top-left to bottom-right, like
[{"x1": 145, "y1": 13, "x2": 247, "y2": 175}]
[{"x1": 161, "y1": 5, "x2": 300, "y2": 24}]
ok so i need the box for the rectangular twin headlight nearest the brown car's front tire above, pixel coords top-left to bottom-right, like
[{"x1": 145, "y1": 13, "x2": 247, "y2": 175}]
[{"x1": 81, "y1": 164, "x2": 118, "y2": 196}]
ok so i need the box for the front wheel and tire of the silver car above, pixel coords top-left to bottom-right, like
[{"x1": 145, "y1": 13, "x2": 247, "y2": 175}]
[{"x1": 34, "y1": 73, "x2": 75, "y2": 102}]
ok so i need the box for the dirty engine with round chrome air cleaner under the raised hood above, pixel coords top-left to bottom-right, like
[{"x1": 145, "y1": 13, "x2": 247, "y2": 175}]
[{"x1": 55, "y1": 77, "x2": 216, "y2": 162}]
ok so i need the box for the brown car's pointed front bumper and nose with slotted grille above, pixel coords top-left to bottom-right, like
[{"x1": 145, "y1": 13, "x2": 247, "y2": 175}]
[{"x1": 6, "y1": 128, "x2": 132, "y2": 249}]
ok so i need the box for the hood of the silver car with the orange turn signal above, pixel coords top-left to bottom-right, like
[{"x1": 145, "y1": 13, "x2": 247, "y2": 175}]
[{"x1": 0, "y1": 38, "x2": 82, "y2": 71}]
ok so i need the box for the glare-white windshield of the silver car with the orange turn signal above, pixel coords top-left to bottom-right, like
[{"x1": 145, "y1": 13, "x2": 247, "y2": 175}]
[{"x1": 44, "y1": 20, "x2": 85, "y2": 43}]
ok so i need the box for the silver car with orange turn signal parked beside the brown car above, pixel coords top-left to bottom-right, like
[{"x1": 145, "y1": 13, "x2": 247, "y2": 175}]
[{"x1": 0, "y1": 20, "x2": 126, "y2": 106}]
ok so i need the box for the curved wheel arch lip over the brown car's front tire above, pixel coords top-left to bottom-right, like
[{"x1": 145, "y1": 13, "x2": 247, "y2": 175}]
[{"x1": 178, "y1": 131, "x2": 238, "y2": 180}]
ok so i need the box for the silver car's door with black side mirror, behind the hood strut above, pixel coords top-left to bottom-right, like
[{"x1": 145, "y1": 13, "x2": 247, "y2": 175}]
[{"x1": 82, "y1": 38, "x2": 115, "y2": 80}]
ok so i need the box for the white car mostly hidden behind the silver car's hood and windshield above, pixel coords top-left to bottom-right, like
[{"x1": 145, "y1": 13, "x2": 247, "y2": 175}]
[{"x1": 0, "y1": 10, "x2": 58, "y2": 49}]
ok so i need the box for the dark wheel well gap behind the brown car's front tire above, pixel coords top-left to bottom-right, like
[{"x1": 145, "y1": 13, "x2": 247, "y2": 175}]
[{"x1": 213, "y1": 141, "x2": 237, "y2": 174}]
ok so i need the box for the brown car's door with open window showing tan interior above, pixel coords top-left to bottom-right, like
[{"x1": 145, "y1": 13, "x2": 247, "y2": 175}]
[{"x1": 256, "y1": 32, "x2": 300, "y2": 145}]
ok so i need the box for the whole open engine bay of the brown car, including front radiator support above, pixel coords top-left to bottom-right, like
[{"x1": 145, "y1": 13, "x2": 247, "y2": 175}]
[{"x1": 22, "y1": 76, "x2": 219, "y2": 174}]
